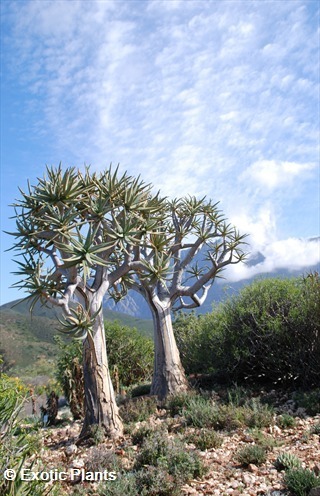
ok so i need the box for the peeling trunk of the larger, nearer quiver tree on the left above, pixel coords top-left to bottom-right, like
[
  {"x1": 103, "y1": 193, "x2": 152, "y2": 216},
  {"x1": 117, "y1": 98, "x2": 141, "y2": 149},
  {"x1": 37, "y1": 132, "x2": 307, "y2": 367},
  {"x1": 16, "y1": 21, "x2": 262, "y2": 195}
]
[{"x1": 80, "y1": 294, "x2": 123, "y2": 440}]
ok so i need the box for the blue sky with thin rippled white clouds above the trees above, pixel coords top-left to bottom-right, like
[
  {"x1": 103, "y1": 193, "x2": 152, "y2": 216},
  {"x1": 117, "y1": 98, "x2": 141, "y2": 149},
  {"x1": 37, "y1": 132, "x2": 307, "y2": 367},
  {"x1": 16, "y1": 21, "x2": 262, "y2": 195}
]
[{"x1": 1, "y1": 0, "x2": 320, "y2": 303}]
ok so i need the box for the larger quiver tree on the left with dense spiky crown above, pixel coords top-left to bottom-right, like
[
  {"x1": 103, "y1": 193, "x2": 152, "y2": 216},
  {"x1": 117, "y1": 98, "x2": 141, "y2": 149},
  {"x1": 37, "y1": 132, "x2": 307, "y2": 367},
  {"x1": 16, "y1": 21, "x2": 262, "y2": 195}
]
[{"x1": 10, "y1": 166, "x2": 161, "y2": 439}]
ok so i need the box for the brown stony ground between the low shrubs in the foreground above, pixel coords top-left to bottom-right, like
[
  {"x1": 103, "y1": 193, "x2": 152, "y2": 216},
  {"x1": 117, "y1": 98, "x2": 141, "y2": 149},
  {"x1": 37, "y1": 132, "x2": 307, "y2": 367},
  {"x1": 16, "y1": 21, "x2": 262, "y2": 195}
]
[{"x1": 23, "y1": 392, "x2": 320, "y2": 496}]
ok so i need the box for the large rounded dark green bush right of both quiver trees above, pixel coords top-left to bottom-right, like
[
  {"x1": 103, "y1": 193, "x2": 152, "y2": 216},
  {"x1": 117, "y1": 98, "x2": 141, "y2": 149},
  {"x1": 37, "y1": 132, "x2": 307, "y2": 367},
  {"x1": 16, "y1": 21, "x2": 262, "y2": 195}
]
[{"x1": 195, "y1": 274, "x2": 320, "y2": 387}]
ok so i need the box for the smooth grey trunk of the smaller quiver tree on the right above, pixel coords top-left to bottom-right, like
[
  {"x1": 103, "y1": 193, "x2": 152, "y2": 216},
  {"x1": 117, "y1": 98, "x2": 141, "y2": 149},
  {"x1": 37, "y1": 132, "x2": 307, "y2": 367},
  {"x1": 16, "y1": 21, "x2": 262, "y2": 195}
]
[{"x1": 151, "y1": 300, "x2": 188, "y2": 400}]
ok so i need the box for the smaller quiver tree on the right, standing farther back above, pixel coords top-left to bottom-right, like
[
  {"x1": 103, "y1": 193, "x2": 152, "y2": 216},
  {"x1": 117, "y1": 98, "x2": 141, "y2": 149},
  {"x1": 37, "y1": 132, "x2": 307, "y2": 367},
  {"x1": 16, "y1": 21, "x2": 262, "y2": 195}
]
[{"x1": 114, "y1": 197, "x2": 245, "y2": 399}]
